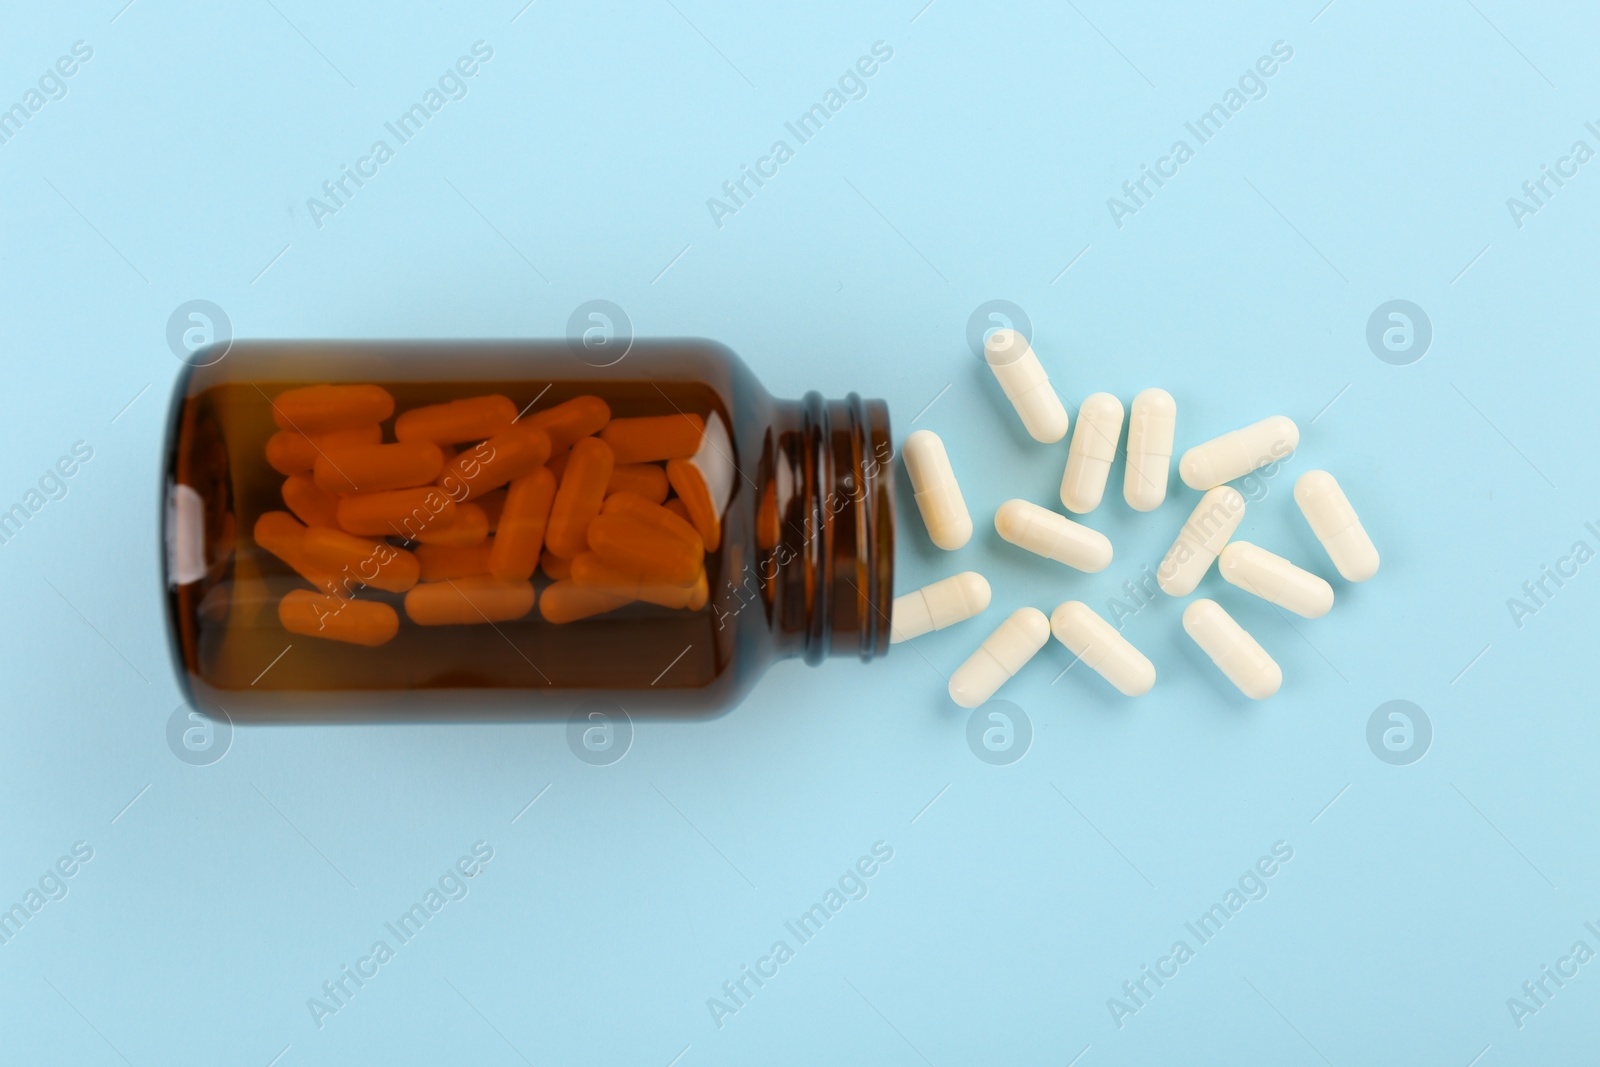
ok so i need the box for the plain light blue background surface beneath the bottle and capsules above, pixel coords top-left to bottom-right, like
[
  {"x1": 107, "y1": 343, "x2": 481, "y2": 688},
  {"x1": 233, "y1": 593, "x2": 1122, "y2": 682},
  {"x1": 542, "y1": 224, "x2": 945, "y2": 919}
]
[{"x1": 0, "y1": 0, "x2": 1600, "y2": 1067}]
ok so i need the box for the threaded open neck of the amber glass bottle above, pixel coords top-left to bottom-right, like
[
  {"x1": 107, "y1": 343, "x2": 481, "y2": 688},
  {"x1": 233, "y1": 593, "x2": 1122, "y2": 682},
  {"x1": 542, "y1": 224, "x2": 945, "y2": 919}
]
[{"x1": 757, "y1": 392, "x2": 894, "y2": 664}]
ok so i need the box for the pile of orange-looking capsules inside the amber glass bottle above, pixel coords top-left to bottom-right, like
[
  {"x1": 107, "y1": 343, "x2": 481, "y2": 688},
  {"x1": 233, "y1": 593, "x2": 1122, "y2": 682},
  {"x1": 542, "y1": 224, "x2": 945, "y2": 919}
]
[{"x1": 254, "y1": 386, "x2": 722, "y2": 646}]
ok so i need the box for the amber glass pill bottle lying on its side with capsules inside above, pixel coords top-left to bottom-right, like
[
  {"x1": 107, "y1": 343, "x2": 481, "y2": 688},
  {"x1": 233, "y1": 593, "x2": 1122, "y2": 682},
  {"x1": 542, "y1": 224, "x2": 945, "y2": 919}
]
[{"x1": 163, "y1": 341, "x2": 894, "y2": 720}]
